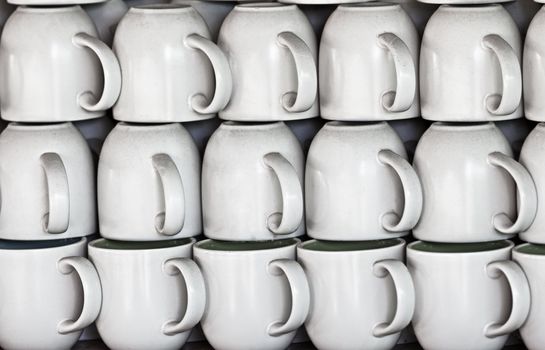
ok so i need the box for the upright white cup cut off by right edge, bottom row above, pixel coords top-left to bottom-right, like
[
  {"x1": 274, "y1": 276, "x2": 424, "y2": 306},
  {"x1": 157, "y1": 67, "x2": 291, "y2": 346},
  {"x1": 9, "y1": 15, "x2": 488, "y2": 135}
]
[{"x1": 513, "y1": 243, "x2": 545, "y2": 350}]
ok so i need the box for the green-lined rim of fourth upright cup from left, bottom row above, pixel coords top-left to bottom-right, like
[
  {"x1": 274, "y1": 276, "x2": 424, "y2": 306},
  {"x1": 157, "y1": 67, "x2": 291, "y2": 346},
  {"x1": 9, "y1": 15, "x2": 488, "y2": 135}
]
[{"x1": 297, "y1": 237, "x2": 406, "y2": 255}]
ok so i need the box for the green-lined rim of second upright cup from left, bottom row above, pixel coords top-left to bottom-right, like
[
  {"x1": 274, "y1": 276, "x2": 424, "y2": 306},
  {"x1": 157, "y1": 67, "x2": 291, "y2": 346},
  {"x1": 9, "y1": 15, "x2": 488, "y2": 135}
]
[{"x1": 88, "y1": 237, "x2": 197, "y2": 254}]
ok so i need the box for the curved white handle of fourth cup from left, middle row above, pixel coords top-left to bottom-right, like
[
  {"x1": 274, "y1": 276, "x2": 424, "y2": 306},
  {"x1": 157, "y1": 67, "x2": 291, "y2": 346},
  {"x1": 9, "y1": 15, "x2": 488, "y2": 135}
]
[{"x1": 378, "y1": 149, "x2": 423, "y2": 232}]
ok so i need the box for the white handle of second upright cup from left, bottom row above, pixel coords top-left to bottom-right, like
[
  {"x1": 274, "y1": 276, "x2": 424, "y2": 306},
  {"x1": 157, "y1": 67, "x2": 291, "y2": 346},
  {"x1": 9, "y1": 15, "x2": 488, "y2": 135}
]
[{"x1": 163, "y1": 258, "x2": 206, "y2": 335}]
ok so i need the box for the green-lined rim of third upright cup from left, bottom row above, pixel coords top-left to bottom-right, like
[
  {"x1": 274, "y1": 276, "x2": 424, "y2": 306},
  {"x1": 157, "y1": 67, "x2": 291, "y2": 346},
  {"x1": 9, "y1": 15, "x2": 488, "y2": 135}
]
[{"x1": 193, "y1": 237, "x2": 301, "y2": 255}]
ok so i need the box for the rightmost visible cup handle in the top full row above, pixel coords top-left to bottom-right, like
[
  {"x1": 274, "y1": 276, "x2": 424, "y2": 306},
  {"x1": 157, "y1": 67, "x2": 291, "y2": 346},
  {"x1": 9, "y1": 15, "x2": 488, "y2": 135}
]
[{"x1": 482, "y1": 34, "x2": 522, "y2": 116}]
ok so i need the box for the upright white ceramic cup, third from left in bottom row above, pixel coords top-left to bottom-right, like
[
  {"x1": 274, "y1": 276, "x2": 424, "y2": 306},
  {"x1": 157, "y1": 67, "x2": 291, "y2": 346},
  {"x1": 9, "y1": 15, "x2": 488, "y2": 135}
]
[{"x1": 193, "y1": 238, "x2": 310, "y2": 350}]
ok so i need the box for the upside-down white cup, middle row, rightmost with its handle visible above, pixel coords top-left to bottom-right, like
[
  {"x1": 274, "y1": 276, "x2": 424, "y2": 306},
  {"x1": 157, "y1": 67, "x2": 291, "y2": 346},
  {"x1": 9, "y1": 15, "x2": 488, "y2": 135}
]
[{"x1": 413, "y1": 123, "x2": 537, "y2": 242}]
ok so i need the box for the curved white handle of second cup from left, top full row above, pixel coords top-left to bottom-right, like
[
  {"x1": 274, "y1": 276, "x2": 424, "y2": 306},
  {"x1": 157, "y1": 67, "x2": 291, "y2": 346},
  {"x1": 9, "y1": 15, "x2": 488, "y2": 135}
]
[{"x1": 185, "y1": 34, "x2": 233, "y2": 114}]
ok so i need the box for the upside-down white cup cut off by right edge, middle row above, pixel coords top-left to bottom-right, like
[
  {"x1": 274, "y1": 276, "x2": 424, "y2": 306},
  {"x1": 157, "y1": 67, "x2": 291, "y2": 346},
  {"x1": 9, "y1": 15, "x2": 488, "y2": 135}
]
[{"x1": 519, "y1": 123, "x2": 545, "y2": 244}]
